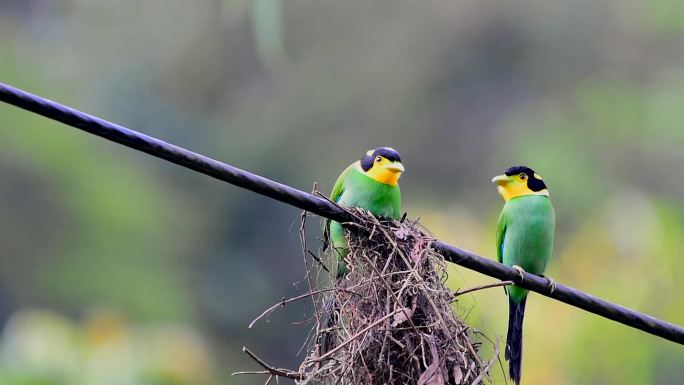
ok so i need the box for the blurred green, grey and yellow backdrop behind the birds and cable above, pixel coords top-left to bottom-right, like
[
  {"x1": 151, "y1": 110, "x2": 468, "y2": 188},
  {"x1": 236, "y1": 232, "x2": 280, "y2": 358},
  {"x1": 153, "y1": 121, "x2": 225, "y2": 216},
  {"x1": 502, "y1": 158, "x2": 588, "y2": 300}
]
[{"x1": 0, "y1": 0, "x2": 684, "y2": 385}]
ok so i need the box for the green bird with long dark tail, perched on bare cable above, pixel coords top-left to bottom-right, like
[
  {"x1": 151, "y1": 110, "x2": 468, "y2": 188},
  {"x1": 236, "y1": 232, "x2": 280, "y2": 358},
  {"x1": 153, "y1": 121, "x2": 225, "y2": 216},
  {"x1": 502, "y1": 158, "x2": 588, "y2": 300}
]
[{"x1": 492, "y1": 166, "x2": 556, "y2": 384}]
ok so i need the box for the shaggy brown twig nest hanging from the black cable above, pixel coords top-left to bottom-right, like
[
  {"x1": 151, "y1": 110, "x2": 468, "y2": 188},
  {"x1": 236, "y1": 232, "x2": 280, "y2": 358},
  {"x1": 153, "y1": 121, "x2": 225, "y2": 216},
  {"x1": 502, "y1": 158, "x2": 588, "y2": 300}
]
[{"x1": 240, "y1": 209, "x2": 498, "y2": 385}]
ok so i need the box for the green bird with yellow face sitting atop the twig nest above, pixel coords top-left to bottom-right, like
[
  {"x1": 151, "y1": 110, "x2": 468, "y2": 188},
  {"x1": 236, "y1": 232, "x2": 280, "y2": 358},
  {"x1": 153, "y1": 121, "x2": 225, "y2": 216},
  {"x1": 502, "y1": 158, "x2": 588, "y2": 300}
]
[{"x1": 330, "y1": 147, "x2": 404, "y2": 277}]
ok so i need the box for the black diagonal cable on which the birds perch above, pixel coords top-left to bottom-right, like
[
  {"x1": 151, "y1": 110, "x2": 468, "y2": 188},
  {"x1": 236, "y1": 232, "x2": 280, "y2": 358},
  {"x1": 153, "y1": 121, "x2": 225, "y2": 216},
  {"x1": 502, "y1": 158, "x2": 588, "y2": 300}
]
[{"x1": 0, "y1": 83, "x2": 684, "y2": 345}]
